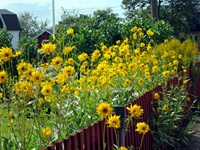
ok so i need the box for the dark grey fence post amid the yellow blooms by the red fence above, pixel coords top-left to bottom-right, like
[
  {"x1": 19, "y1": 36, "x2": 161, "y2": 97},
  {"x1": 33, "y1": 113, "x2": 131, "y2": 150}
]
[{"x1": 114, "y1": 106, "x2": 126, "y2": 147}]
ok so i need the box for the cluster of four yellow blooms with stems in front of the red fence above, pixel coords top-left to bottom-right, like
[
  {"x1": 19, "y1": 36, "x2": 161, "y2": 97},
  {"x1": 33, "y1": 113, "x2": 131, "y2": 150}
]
[{"x1": 96, "y1": 102, "x2": 150, "y2": 150}]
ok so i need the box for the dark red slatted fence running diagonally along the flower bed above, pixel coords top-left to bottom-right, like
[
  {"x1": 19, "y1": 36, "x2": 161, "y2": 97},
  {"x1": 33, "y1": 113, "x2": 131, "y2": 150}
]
[{"x1": 42, "y1": 63, "x2": 200, "y2": 150}]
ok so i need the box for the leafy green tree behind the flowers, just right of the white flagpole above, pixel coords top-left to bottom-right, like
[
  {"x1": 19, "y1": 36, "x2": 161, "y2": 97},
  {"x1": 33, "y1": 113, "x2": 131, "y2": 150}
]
[{"x1": 56, "y1": 8, "x2": 121, "y2": 53}]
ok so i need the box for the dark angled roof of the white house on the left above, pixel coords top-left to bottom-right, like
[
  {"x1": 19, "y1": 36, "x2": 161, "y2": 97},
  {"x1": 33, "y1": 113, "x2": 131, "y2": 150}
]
[{"x1": 0, "y1": 9, "x2": 21, "y2": 30}]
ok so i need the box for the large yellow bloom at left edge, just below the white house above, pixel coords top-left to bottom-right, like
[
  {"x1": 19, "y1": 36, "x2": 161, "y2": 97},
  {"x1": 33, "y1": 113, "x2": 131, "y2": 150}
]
[{"x1": 0, "y1": 47, "x2": 14, "y2": 62}]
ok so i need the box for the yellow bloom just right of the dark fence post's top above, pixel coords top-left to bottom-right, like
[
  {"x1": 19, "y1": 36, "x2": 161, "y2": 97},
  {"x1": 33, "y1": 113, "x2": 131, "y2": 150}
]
[{"x1": 126, "y1": 104, "x2": 144, "y2": 117}]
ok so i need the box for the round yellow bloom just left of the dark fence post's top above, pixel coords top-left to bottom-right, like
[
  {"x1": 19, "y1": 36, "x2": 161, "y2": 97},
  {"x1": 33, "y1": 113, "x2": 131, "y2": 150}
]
[{"x1": 96, "y1": 102, "x2": 113, "y2": 117}]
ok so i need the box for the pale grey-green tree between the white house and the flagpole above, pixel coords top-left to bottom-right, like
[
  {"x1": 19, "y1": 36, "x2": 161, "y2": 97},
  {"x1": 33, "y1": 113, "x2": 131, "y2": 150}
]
[{"x1": 18, "y1": 12, "x2": 48, "y2": 38}]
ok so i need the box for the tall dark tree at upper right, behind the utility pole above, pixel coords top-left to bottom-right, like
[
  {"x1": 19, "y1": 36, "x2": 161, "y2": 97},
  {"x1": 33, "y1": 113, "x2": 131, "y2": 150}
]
[{"x1": 122, "y1": 0, "x2": 200, "y2": 35}]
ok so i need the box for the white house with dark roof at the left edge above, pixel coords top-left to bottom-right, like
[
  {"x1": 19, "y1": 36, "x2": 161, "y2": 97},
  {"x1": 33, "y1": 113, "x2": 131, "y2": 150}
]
[{"x1": 0, "y1": 9, "x2": 21, "y2": 49}]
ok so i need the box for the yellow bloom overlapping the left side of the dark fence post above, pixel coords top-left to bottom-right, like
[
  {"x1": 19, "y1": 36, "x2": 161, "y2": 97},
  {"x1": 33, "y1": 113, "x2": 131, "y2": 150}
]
[{"x1": 106, "y1": 115, "x2": 120, "y2": 129}]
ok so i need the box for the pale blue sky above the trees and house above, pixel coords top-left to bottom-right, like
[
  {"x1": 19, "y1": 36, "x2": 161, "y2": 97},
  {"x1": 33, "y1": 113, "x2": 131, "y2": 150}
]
[{"x1": 0, "y1": 0, "x2": 124, "y2": 25}]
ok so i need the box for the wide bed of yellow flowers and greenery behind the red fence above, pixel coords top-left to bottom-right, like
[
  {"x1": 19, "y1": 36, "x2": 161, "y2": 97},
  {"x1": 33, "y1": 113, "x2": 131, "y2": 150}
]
[{"x1": 0, "y1": 27, "x2": 197, "y2": 149}]
